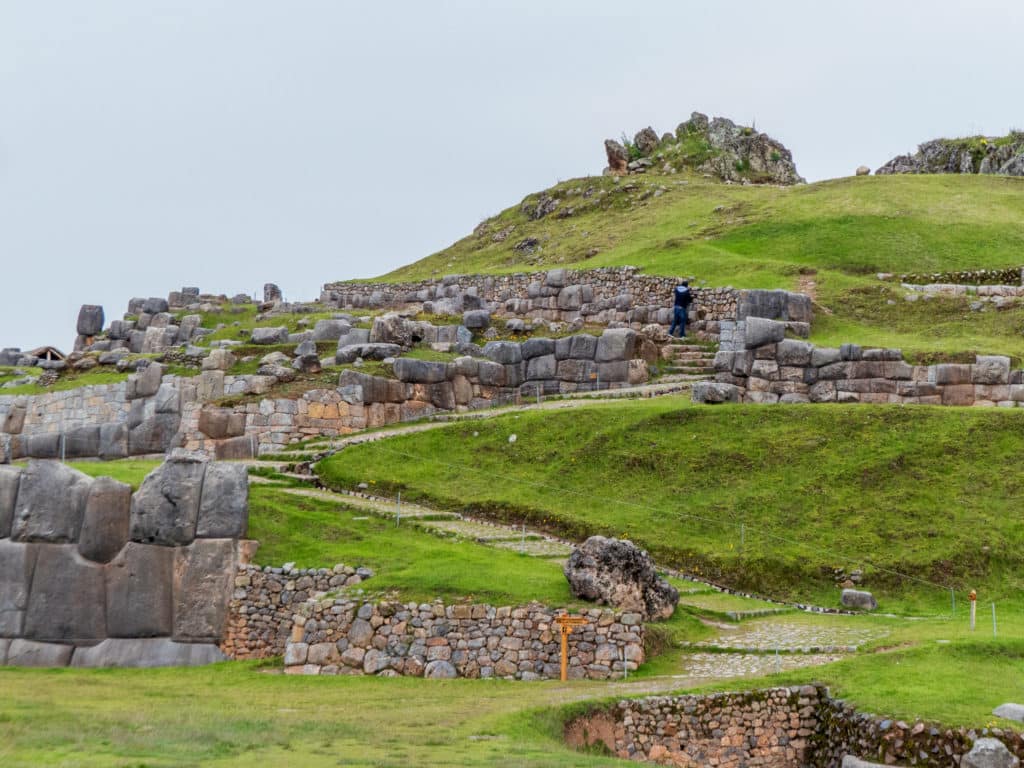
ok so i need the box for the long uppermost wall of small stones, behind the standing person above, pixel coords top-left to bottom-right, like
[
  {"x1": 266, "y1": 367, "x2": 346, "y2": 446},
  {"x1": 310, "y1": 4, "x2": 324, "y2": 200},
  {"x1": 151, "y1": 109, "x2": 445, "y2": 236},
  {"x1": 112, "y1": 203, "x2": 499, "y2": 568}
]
[{"x1": 321, "y1": 266, "x2": 811, "y2": 335}]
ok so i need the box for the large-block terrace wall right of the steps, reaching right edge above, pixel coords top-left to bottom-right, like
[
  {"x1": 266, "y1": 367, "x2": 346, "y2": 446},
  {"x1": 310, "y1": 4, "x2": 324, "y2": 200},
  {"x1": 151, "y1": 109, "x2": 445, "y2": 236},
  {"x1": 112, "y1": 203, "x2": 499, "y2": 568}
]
[{"x1": 693, "y1": 317, "x2": 1024, "y2": 408}]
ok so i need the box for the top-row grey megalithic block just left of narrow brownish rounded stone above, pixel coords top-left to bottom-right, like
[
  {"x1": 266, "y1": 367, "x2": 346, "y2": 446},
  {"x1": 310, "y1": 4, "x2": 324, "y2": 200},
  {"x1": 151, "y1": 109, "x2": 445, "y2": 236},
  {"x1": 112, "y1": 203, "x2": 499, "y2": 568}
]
[{"x1": 11, "y1": 461, "x2": 92, "y2": 543}]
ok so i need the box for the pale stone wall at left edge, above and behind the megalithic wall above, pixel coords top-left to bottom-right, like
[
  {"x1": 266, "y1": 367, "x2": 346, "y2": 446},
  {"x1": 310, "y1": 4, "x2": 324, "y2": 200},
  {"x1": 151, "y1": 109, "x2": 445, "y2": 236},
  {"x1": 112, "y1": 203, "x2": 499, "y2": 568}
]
[{"x1": 0, "y1": 364, "x2": 188, "y2": 463}]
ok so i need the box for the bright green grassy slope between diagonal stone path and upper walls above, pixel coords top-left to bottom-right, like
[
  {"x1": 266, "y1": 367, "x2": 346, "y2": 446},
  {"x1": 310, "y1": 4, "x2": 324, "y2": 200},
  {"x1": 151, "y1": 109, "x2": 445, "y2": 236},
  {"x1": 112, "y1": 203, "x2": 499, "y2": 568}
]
[{"x1": 319, "y1": 398, "x2": 1024, "y2": 605}]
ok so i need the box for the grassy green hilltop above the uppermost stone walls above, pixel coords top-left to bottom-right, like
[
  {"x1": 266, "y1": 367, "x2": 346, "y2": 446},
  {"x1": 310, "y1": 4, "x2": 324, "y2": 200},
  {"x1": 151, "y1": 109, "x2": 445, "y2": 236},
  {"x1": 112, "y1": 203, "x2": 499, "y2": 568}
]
[{"x1": 381, "y1": 174, "x2": 1024, "y2": 355}]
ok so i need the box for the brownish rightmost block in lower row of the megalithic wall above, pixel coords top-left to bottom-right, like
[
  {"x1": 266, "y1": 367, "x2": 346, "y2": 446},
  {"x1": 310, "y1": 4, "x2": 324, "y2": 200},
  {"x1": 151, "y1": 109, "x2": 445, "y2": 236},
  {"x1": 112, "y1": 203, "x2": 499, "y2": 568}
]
[{"x1": 172, "y1": 539, "x2": 237, "y2": 642}]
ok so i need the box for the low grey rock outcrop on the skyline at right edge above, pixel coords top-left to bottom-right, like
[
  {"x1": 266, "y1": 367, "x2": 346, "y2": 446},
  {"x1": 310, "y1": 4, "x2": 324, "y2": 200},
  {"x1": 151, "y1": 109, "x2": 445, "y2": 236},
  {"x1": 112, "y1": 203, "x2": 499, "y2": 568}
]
[{"x1": 874, "y1": 131, "x2": 1024, "y2": 176}]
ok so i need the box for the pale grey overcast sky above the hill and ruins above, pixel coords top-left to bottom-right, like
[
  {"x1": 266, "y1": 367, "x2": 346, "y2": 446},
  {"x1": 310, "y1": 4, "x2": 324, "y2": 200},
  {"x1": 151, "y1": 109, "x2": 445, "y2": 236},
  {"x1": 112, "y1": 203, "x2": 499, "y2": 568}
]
[{"x1": 0, "y1": 0, "x2": 1024, "y2": 349}]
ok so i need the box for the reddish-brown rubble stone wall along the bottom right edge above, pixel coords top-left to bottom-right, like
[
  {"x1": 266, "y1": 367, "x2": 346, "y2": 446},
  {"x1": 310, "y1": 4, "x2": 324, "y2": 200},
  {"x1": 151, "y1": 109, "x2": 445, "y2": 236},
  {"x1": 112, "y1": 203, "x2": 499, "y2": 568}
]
[{"x1": 565, "y1": 685, "x2": 1024, "y2": 768}]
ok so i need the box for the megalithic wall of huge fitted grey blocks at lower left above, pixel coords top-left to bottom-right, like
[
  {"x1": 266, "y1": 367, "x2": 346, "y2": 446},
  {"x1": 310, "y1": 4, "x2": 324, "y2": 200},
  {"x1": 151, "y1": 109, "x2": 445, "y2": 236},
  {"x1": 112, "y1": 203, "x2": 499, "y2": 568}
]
[{"x1": 0, "y1": 452, "x2": 249, "y2": 667}]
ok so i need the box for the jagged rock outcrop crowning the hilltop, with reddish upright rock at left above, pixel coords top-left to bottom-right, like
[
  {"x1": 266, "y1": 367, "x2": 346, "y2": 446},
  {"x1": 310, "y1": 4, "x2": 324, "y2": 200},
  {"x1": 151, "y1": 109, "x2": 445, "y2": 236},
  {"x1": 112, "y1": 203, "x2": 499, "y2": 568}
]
[{"x1": 604, "y1": 112, "x2": 804, "y2": 184}]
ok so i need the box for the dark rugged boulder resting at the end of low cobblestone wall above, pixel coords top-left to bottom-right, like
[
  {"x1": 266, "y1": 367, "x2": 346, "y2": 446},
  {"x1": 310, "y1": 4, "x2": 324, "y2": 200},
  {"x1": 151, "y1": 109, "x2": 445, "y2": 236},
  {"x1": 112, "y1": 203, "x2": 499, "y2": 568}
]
[{"x1": 563, "y1": 536, "x2": 679, "y2": 620}]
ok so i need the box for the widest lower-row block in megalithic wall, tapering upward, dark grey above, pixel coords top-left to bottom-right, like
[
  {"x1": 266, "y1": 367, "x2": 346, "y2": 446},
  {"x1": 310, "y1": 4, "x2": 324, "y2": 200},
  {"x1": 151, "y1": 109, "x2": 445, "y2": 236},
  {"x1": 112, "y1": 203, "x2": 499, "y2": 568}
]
[{"x1": 25, "y1": 544, "x2": 106, "y2": 642}]
